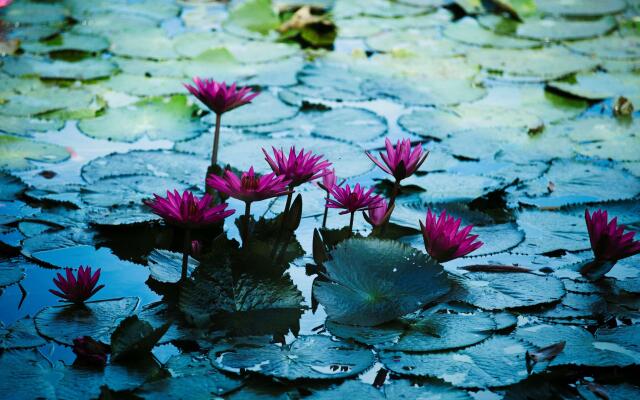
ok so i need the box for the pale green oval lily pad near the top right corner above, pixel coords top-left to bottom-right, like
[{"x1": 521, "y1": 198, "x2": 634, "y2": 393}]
[{"x1": 516, "y1": 17, "x2": 617, "y2": 41}]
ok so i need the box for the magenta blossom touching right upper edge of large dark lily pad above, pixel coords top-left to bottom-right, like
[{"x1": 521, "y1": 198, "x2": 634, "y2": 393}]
[{"x1": 420, "y1": 210, "x2": 482, "y2": 262}]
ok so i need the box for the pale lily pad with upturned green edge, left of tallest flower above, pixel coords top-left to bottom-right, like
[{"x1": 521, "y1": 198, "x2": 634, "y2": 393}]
[{"x1": 78, "y1": 96, "x2": 206, "y2": 142}]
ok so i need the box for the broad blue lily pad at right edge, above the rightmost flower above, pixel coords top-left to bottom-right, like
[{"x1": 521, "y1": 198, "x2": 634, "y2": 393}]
[{"x1": 518, "y1": 160, "x2": 640, "y2": 208}]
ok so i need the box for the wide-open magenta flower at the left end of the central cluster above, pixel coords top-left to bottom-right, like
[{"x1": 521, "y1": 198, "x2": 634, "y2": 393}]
[{"x1": 145, "y1": 190, "x2": 236, "y2": 229}]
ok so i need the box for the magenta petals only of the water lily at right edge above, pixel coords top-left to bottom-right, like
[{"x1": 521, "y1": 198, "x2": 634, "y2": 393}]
[{"x1": 584, "y1": 210, "x2": 640, "y2": 262}]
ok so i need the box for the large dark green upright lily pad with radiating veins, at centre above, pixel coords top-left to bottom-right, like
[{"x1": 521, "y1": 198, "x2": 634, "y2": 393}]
[{"x1": 313, "y1": 239, "x2": 449, "y2": 326}]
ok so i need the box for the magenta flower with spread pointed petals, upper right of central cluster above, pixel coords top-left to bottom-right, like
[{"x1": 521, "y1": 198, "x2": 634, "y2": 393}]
[{"x1": 367, "y1": 139, "x2": 429, "y2": 182}]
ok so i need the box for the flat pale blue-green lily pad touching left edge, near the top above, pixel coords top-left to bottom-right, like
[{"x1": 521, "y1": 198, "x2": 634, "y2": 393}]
[{"x1": 2, "y1": 55, "x2": 116, "y2": 80}]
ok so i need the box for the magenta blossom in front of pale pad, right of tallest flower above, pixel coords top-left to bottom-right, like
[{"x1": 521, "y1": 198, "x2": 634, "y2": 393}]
[{"x1": 262, "y1": 146, "x2": 331, "y2": 187}]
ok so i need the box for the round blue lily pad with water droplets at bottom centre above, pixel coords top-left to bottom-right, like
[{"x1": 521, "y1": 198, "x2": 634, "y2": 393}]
[{"x1": 209, "y1": 335, "x2": 374, "y2": 380}]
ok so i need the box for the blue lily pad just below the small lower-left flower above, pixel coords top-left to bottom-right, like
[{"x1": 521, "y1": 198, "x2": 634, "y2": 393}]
[{"x1": 35, "y1": 297, "x2": 138, "y2": 346}]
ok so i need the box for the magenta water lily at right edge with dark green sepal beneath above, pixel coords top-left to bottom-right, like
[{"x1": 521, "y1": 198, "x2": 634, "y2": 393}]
[{"x1": 580, "y1": 210, "x2": 640, "y2": 280}]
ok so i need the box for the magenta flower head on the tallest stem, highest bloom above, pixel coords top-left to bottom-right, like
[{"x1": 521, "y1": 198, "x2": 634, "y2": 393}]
[{"x1": 184, "y1": 77, "x2": 259, "y2": 115}]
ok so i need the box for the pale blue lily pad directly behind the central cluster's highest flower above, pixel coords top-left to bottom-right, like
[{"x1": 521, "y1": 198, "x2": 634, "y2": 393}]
[{"x1": 219, "y1": 137, "x2": 373, "y2": 178}]
